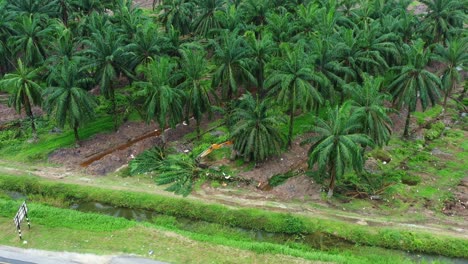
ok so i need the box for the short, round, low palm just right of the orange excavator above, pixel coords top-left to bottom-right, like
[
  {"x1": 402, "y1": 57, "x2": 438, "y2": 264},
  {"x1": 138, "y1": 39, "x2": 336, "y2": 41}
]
[{"x1": 230, "y1": 93, "x2": 286, "y2": 161}]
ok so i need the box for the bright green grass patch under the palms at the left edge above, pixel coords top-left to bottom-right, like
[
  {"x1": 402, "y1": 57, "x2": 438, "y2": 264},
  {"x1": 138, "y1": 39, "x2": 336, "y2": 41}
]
[{"x1": 0, "y1": 116, "x2": 114, "y2": 162}]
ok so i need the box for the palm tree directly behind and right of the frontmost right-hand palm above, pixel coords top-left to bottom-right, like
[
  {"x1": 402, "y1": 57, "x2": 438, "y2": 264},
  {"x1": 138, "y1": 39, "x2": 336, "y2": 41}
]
[{"x1": 351, "y1": 75, "x2": 392, "y2": 147}]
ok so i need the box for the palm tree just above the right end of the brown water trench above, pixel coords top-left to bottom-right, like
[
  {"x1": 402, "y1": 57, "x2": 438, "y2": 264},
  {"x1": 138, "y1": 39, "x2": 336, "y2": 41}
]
[{"x1": 135, "y1": 57, "x2": 185, "y2": 129}]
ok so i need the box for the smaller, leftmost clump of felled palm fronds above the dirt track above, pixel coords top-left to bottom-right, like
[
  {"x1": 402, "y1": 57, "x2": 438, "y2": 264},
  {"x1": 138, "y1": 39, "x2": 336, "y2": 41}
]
[{"x1": 129, "y1": 147, "x2": 166, "y2": 175}]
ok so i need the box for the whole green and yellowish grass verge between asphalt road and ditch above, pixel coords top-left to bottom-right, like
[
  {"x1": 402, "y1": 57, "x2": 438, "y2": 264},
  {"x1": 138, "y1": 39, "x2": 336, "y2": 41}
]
[{"x1": 0, "y1": 199, "x2": 411, "y2": 263}]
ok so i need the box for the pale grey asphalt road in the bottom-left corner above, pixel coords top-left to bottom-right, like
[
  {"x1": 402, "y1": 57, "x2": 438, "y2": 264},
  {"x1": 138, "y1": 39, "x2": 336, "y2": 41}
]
[{"x1": 0, "y1": 246, "x2": 167, "y2": 264}]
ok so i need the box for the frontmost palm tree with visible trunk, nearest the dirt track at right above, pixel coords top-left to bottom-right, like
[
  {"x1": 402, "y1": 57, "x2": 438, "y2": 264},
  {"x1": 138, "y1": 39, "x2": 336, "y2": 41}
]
[{"x1": 303, "y1": 103, "x2": 372, "y2": 198}]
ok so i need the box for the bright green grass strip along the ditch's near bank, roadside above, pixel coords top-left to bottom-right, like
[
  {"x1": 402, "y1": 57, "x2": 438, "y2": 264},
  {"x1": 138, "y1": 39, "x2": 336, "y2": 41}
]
[{"x1": 0, "y1": 198, "x2": 412, "y2": 264}]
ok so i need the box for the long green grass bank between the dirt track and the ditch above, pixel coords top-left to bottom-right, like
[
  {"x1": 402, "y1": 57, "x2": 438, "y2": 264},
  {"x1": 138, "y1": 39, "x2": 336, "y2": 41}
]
[{"x1": 0, "y1": 175, "x2": 468, "y2": 258}]
